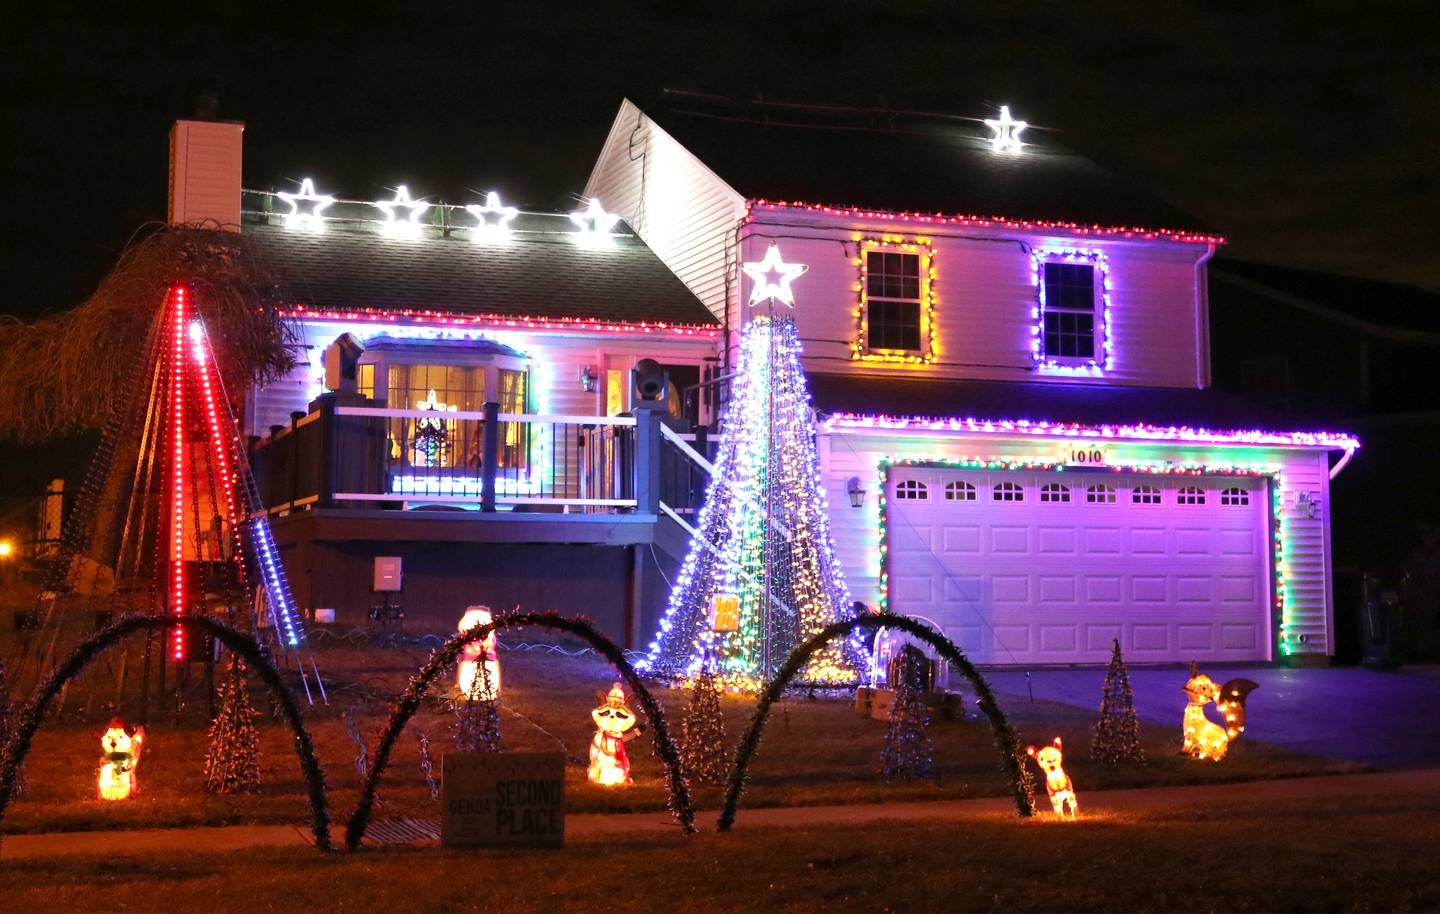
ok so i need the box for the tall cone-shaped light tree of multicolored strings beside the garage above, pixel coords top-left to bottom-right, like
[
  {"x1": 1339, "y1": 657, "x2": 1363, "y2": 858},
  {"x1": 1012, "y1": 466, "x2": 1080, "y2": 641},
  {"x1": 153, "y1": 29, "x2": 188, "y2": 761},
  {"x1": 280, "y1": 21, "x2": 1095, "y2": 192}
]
[{"x1": 639, "y1": 309, "x2": 864, "y2": 688}]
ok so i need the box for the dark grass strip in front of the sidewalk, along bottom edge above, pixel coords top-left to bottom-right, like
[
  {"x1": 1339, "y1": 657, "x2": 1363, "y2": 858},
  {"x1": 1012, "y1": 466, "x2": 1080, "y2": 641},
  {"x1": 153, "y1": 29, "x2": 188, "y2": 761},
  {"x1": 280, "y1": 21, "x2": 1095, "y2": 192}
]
[{"x1": 0, "y1": 795, "x2": 1440, "y2": 914}]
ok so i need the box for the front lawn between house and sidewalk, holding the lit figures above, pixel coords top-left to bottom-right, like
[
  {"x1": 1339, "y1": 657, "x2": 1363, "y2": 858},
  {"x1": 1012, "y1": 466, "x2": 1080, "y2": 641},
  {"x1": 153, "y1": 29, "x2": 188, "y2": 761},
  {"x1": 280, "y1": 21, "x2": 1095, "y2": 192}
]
[{"x1": 3, "y1": 630, "x2": 1358, "y2": 832}]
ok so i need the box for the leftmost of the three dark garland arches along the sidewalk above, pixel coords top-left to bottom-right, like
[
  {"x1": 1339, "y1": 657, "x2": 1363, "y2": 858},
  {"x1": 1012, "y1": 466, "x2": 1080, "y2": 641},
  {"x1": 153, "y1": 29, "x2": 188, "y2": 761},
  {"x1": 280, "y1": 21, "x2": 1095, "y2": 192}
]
[{"x1": 0, "y1": 616, "x2": 330, "y2": 851}]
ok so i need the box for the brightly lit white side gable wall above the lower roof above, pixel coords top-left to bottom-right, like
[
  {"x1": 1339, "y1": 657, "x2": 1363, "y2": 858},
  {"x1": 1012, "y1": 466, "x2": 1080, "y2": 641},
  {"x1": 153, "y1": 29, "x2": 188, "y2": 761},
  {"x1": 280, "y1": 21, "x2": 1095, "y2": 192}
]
[{"x1": 585, "y1": 101, "x2": 744, "y2": 321}]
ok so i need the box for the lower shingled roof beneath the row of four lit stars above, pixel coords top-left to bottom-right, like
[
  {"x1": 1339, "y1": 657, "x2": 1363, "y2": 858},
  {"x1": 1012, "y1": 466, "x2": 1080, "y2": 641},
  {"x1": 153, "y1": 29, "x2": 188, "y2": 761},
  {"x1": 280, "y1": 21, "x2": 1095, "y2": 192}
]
[{"x1": 240, "y1": 201, "x2": 719, "y2": 327}]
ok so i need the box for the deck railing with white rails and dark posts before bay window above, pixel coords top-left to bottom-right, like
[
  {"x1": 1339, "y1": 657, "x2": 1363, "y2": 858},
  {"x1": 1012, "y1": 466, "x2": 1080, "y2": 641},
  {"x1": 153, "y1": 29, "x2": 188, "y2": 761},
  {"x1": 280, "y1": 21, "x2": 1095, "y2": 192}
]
[{"x1": 252, "y1": 396, "x2": 708, "y2": 514}]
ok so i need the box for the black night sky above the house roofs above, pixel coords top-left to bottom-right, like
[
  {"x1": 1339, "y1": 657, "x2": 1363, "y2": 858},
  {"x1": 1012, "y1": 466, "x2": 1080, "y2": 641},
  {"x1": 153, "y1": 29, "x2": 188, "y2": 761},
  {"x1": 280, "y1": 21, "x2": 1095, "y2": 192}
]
[{"x1": 8, "y1": 1, "x2": 1440, "y2": 322}]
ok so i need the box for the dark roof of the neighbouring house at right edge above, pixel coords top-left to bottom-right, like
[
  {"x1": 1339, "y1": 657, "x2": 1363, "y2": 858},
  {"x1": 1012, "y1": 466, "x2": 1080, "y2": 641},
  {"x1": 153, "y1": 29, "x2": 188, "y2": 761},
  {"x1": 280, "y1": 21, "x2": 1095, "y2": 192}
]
[{"x1": 1210, "y1": 258, "x2": 1440, "y2": 341}]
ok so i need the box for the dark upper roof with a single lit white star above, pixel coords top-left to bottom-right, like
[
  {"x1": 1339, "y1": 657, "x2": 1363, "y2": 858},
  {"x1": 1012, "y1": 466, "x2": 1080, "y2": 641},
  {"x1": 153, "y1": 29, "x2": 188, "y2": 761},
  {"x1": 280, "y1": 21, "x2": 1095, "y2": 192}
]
[{"x1": 645, "y1": 92, "x2": 1223, "y2": 240}]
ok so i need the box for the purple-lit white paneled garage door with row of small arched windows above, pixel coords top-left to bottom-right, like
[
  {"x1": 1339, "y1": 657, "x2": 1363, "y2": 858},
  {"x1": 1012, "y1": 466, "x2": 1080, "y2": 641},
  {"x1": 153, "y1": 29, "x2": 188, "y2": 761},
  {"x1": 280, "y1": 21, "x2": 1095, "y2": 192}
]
[{"x1": 886, "y1": 466, "x2": 1272, "y2": 664}]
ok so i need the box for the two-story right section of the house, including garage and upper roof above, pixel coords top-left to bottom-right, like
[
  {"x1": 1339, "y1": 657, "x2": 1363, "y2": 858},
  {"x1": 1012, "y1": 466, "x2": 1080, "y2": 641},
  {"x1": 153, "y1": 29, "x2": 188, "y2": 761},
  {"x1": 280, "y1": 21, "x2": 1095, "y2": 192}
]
[{"x1": 585, "y1": 94, "x2": 1358, "y2": 665}]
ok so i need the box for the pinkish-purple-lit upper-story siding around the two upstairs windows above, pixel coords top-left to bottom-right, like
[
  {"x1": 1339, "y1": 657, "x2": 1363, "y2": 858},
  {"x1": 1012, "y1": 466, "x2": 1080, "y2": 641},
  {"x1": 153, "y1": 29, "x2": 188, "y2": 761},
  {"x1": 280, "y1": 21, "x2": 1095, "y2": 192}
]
[{"x1": 742, "y1": 217, "x2": 1208, "y2": 388}]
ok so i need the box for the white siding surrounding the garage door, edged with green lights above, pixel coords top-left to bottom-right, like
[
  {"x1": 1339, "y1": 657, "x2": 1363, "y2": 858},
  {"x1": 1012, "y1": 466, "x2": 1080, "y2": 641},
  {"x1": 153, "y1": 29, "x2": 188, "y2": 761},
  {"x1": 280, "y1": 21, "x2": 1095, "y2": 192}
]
[{"x1": 819, "y1": 432, "x2": 1333, "y2": 656}]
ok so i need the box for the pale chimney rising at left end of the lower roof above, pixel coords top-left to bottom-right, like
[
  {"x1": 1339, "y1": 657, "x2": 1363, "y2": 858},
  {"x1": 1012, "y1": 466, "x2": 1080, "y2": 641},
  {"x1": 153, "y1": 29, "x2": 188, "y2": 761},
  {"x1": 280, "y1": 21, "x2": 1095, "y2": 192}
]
[{"x1": 168, "y1": 121, "x2": 245, "y2": 232}]
